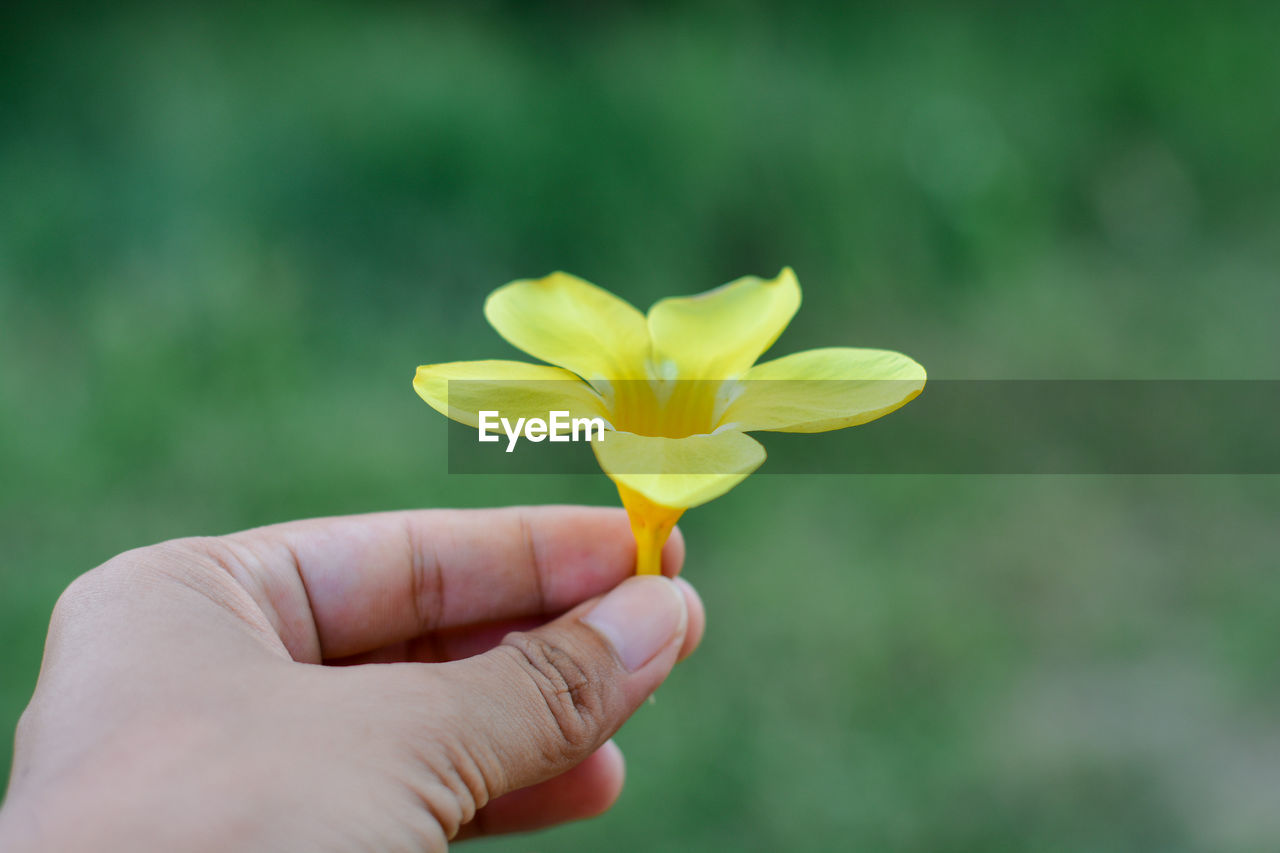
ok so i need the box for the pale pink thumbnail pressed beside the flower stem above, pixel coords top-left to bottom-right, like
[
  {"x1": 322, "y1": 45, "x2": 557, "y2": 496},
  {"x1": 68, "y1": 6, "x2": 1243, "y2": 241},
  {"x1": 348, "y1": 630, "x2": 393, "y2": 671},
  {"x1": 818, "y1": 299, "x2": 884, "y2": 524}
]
[{"x1": 582, "y1": 576, "x2": 689, "y2": 672}]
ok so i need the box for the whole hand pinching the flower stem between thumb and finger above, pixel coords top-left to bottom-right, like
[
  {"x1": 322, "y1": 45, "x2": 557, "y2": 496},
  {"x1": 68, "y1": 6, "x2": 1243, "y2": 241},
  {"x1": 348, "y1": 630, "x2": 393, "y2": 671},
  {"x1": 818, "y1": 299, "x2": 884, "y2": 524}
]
[{"x1": 0, "y1": 506, "x2": 704, "y2": 853}]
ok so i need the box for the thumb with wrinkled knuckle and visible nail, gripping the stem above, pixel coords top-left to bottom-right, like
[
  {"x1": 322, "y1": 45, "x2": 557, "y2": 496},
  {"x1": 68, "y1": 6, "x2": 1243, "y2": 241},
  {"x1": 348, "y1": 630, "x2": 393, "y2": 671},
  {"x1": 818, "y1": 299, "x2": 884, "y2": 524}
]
[{"x1": 424, "y1": 576, "x2": 689, "y2": 799}]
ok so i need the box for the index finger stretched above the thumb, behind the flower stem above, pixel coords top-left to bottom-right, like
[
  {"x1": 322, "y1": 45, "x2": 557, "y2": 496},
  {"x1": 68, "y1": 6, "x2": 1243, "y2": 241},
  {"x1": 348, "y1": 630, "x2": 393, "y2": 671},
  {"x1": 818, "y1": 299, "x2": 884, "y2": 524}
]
[{"x1": 223, "y1": 506, "x2": 685, "y2": 660}]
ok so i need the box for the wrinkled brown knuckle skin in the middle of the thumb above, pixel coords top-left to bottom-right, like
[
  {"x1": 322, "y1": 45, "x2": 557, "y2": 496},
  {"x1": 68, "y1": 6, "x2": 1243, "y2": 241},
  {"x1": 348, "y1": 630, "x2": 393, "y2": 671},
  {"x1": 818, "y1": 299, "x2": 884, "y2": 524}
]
[{"x1": 504, "y1": 633, "x2": 608, "y2": 760}]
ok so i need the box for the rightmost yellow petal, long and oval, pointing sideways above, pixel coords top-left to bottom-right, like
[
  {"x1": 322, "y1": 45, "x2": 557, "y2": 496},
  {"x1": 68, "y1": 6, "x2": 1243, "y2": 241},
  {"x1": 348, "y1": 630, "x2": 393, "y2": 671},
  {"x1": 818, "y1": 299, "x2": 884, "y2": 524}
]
[{"x1": 719, "y1": 347, "x2": 925, "y2": 433}]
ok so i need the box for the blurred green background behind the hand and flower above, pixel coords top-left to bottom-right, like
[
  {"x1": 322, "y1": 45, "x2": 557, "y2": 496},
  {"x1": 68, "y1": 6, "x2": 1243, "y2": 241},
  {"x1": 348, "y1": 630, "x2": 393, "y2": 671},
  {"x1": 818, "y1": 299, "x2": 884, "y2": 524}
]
[{"x1": 0, "y1": 0, "x2": 1280, "y2": 853}]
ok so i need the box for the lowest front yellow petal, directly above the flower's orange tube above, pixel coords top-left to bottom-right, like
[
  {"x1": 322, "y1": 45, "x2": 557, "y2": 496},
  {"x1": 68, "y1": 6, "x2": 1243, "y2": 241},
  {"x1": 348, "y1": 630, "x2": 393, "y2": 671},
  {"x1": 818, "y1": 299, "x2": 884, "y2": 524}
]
[{"x1": 591, "y1": 430, "x2": 764, "y2": 510}]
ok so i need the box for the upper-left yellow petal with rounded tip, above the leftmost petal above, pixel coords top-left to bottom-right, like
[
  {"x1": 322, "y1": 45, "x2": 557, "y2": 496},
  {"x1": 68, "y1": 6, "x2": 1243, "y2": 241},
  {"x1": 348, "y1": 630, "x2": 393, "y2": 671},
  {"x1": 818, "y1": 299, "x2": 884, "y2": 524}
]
[{"x1": 484, "y1": 273, "x2": 649, "y2": 382}]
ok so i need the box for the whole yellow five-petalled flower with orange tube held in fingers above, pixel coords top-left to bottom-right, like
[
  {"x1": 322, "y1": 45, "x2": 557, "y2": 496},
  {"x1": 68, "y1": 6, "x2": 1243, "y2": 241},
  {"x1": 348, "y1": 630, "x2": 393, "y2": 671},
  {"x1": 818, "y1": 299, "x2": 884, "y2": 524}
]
[{"x1": 413, "y1": 268, "x2": 925, "y2": 574}]
